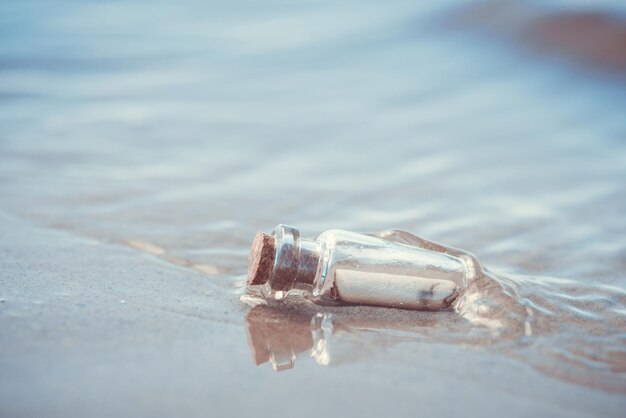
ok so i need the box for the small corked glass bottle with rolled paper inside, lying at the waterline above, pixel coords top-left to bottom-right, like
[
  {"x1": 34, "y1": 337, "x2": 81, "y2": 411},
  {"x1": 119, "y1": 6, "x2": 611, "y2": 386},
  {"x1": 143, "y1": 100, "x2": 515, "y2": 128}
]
[{"x1": 248, "y1": 225, "x2": 481, "y2": 310}]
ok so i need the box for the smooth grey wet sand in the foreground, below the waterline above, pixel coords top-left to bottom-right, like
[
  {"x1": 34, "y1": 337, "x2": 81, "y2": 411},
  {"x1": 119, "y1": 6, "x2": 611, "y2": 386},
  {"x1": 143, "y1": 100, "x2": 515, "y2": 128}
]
[{"x1": 0, "y1": 214, "x2": 626, "y2": 417}]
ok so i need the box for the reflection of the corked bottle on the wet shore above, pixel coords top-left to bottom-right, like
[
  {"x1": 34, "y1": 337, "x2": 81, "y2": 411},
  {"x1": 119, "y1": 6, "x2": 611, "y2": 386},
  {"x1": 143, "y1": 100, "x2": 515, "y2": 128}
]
[{"x1": 246, "y1": 299, "x2": 444, "y2": 371}]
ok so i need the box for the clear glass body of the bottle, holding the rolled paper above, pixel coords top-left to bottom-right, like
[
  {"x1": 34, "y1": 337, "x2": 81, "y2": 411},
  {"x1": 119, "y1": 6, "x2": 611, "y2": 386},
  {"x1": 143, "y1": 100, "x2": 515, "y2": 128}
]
[{"x1": 313, "y1": 230, "x2": 466, "y2": 310}]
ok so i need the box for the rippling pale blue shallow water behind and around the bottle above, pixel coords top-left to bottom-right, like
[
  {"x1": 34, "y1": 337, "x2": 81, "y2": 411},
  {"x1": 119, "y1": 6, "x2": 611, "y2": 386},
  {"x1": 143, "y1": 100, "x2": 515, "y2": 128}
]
[{"x1": 0, "y1": 1, "x2": 626, "y2": 413}]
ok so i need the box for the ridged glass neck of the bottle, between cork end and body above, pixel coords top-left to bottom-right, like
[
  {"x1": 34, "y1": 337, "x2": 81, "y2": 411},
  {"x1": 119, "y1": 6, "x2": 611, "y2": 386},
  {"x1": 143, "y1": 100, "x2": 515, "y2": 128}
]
[{"x1": 269, "y1": 225, "x2": 321, "y2": 291}]
